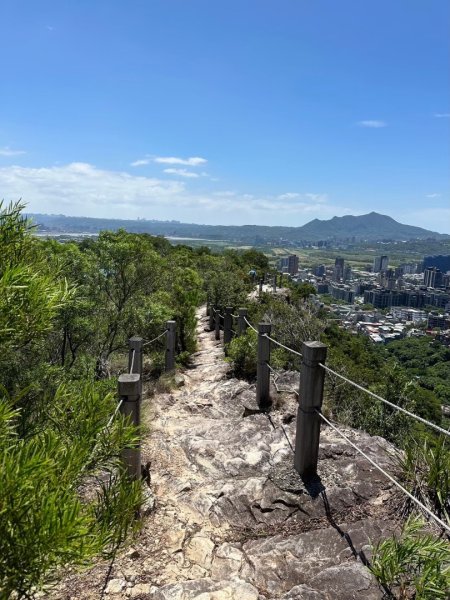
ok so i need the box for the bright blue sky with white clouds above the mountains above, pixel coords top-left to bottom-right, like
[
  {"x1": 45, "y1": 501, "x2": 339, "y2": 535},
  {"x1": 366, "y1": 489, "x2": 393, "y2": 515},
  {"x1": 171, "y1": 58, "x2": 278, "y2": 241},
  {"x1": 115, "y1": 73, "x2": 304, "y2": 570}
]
[{"x1": 0, "y1": 0, "x2": 450, "y2": 233}]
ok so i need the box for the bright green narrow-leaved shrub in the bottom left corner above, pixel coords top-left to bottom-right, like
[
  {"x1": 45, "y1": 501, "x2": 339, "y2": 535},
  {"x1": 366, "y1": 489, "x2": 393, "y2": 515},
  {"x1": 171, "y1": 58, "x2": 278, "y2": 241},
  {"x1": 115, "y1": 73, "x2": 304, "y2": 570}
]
[{"x1": 0, "y1": 386, "x2": 141, "y2": 598}]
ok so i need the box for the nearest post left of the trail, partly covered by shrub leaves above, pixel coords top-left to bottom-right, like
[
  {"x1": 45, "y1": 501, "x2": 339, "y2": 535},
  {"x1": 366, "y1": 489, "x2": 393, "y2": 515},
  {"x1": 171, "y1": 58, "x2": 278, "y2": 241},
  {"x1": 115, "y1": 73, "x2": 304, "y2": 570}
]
[{"x1": 119, "y1": 373, "x2": 142, "y2": 479}]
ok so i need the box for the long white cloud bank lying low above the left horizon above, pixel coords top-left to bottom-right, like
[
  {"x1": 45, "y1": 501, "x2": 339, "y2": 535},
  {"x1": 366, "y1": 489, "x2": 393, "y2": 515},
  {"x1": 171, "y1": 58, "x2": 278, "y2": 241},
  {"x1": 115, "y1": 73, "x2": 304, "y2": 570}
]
[{"x1": 0, "y1": 162, "x2": 340, "y2": 225}]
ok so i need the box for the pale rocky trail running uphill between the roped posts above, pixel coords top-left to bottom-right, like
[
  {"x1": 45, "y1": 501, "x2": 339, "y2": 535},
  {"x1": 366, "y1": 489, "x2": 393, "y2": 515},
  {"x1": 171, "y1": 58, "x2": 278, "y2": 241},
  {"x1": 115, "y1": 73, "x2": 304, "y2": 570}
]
[{"x1": 51, "y1": 309, "x2": 400, "y2": 600}]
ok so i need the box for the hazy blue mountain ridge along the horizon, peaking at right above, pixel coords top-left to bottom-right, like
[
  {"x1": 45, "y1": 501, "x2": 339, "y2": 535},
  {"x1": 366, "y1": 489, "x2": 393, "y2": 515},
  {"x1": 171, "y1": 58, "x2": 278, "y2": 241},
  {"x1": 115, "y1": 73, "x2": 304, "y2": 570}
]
[{"x1": 28, "y1": 212, "x2": 449, "y2": 244}]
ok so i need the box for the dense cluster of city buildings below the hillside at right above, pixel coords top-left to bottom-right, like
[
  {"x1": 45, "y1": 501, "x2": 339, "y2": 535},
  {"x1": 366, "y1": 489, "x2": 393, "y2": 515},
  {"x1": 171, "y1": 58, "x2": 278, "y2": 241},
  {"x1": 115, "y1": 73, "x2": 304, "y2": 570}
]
[{"x1": 279, "y1": 255, "x2": 450, "y2": 344}]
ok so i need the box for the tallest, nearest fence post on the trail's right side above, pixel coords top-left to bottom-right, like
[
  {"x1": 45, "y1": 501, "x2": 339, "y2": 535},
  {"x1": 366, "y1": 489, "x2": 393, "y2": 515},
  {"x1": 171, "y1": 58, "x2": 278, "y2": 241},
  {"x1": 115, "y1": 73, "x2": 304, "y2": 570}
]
[{"x1": 294, "y1": 342, "x2": 327, "y2": 477}]
